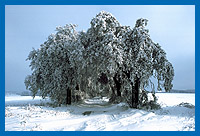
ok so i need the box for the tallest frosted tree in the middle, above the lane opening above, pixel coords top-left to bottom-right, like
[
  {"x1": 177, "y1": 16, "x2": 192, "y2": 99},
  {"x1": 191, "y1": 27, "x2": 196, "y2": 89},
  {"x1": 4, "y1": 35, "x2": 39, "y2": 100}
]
[{"x1": 79, "y1": 11, "x2": 123, "y2": 99}]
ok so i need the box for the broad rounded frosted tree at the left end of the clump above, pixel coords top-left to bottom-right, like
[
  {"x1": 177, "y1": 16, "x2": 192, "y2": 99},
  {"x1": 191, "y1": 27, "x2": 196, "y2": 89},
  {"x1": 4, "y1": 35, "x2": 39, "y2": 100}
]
[{"x1": 25, "y1": 25, "x2": 78, "y2": 104}]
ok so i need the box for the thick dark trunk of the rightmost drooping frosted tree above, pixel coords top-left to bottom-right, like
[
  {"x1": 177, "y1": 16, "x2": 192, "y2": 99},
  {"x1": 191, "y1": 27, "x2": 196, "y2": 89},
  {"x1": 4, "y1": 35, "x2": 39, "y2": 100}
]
[{"x1": 132, "y1": 78, "x2": 140, "y2": 108}]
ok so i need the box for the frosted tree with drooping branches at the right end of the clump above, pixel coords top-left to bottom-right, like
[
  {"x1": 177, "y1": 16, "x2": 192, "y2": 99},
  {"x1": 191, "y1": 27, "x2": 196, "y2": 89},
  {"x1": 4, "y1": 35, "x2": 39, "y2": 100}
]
[{"x1": 119, "y1": 18, "x2": 174, "y2": 108}]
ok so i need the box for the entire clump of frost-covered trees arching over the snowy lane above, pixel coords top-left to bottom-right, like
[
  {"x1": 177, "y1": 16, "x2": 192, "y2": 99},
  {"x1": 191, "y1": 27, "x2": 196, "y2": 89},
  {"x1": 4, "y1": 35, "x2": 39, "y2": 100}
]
[{"x1": 25, "y1": 11, "x2": 174, "y2": 108}]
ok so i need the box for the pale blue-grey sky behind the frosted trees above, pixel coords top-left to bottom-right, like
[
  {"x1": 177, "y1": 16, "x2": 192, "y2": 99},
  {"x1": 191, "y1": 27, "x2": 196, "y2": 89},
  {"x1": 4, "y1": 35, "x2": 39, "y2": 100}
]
[{"x1": 5, "y1": 5, "x2": 195, "y2": 91}]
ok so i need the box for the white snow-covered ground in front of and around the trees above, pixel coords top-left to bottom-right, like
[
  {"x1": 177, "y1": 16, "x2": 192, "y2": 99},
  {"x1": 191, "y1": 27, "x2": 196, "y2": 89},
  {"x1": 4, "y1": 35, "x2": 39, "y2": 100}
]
[{"x1": 5, "y1": 93, "x2": 195, "y2": 131}]
